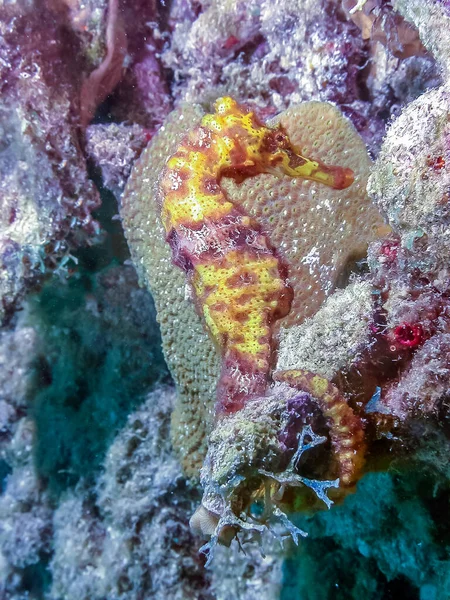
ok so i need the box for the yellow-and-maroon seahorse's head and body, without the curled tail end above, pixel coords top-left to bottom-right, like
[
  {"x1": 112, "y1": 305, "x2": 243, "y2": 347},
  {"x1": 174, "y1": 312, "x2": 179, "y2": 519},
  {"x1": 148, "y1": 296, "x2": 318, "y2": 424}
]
[{"x1": 160, "y1": 97, "x2": 354, "y2": 415}]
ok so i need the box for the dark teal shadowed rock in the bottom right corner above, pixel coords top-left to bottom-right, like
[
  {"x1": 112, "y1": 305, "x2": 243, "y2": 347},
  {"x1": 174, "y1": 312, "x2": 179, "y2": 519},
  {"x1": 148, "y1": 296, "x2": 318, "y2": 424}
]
[{"x1": 282, "y1": 464, "x2": 450, "y2": 600}]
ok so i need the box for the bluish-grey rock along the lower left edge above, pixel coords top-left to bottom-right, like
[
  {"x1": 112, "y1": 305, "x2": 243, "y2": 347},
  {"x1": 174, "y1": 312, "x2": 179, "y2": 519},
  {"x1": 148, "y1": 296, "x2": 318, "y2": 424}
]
[{"x1": 0, "y1": 318, "x2": 53, "y2": 598}]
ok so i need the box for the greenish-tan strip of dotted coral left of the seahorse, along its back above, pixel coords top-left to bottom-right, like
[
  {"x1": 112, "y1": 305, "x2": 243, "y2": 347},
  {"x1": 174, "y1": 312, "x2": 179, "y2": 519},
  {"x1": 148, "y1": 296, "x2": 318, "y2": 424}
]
[{"x1": 121, "y1": 105, "x2": 219, "y2": 476}]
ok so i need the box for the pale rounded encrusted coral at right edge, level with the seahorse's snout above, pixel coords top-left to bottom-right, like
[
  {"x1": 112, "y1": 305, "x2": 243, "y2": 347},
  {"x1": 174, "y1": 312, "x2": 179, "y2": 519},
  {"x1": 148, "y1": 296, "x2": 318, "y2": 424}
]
[{"x1": 368, "y1": 85, "x2": 450, "y2": 261}]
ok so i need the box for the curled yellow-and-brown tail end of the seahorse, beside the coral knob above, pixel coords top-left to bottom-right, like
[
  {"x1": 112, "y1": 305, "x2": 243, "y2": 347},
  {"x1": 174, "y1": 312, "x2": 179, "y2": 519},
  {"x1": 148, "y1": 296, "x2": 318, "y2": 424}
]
[{"x1": 274, "y1": 369, "x2": 365, "y2": 488}]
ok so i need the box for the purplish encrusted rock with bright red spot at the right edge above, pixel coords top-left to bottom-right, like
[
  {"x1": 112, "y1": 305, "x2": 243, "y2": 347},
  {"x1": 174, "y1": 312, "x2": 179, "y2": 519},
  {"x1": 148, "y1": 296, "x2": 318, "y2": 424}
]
[{"x1": 369, "y1": 236, "x2": 450, "y2": 429}]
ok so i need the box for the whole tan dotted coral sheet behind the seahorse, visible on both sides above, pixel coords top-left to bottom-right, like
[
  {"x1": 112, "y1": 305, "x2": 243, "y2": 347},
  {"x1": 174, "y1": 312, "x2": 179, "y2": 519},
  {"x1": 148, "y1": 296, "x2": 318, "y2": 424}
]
[{"x1": 121, "y1": 96, "x2": 382, "y2": 474}]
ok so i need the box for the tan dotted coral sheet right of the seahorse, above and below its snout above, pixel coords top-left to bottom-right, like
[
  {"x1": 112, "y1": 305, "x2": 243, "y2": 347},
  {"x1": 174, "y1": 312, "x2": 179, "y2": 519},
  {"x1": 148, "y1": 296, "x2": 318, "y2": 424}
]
[{"x1": 227, "y1": 102, "x2": 384, "y2": 328}]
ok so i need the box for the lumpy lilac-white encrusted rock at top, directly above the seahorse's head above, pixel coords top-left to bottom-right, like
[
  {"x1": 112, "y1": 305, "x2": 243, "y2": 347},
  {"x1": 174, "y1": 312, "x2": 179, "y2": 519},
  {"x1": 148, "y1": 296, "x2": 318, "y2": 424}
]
[{"x1": 162, "y1": 0, "x2": 365, "y2": 112}]
